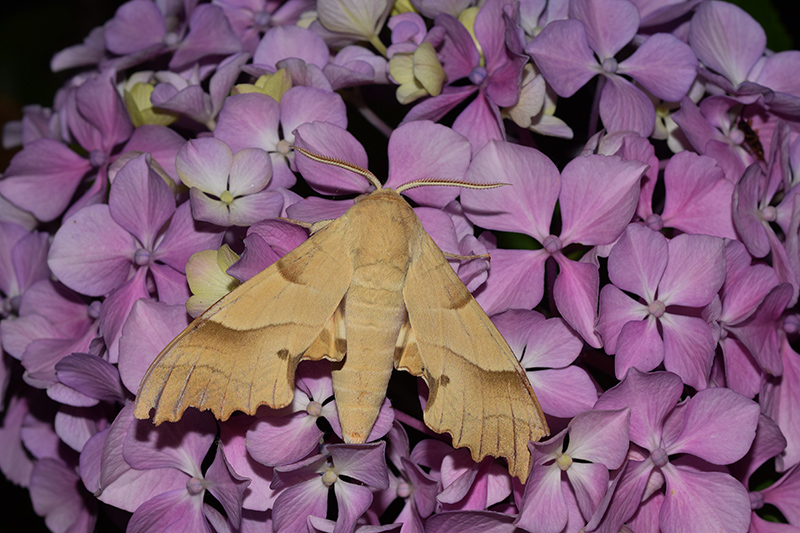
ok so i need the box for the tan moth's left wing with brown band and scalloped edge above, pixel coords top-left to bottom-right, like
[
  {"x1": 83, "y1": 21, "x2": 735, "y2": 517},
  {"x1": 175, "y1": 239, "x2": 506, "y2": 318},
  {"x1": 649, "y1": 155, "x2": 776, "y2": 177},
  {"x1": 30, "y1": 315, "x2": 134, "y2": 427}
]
[{"x1": 134, "y1": 217, "x2": 353, "y2": 424}]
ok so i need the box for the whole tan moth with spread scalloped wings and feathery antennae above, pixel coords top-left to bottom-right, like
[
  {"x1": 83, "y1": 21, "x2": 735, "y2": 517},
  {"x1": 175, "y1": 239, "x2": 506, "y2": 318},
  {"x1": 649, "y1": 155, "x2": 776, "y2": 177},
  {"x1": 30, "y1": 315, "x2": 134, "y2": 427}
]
[{"x1": 135, "y1": 147, "x2": 549, "y2": 482}]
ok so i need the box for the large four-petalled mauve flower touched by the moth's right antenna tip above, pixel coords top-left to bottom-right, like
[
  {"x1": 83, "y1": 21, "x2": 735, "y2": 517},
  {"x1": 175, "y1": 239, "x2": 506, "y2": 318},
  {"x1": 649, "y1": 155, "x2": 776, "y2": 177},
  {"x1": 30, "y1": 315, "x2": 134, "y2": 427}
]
[{"x1": 461, "y1": 141, "x2": 646, "y2": 347}]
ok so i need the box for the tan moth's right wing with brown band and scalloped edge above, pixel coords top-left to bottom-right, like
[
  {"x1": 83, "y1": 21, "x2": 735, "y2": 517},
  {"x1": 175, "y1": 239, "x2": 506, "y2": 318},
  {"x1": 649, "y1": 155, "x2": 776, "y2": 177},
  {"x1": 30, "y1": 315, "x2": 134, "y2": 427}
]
[{"x1": 404, "y1": 234, "x2": 549, "y2": 482}]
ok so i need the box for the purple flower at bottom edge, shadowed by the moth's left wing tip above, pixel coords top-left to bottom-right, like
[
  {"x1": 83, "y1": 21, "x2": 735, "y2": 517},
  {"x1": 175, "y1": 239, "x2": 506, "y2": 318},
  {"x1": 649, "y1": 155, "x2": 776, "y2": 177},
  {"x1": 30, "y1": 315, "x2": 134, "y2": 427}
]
[{"x1": 90, "y1": 404, "x2": 249, "y2": 532}]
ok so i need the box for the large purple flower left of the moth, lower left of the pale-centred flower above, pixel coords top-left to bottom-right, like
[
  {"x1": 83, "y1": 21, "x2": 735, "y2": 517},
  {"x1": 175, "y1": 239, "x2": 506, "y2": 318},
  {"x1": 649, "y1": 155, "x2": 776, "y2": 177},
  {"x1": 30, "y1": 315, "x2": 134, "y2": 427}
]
[{"x1": 49, "y1": 155, "x2": 221, "y2": 362}]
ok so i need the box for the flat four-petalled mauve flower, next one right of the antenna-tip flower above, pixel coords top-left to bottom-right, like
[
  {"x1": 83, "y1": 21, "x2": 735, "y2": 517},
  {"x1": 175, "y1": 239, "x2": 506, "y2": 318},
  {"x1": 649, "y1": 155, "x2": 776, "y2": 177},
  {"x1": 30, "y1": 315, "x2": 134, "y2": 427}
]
[{"x1": 597, "y1": 224, "x2": 725, "y2": 389}]
